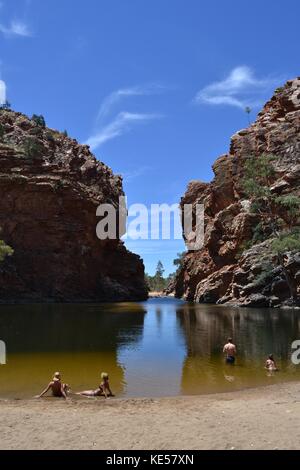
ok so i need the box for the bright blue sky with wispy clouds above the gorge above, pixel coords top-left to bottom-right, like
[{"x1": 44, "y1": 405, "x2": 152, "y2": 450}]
[{"x1": 0, "y1": 0, "x2": 300, "y2": 273}]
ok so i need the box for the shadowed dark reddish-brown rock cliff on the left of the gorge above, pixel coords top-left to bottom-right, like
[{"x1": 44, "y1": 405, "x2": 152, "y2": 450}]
[{"x1": 0, "y1": 110, "x2": 147, "y2": 302}]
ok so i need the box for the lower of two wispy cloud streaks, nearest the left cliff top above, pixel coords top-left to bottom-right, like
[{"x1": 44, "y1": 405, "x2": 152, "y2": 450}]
[{"x1": 86, "y1": 112, "x2": 162, "y2": 150}]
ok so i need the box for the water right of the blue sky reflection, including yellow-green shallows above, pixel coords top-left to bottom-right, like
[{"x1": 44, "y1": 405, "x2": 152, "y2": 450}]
[{"x1": 176, "y1": 304, "x2": 300, "y2": 394}]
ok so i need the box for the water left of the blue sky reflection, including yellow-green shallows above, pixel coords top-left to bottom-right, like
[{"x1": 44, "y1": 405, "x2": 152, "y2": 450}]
[{"x1": 0, "y1": 304, "x2": 146, "y2": 397}]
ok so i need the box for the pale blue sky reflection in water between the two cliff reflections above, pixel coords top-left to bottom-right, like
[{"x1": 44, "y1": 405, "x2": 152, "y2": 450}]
[{"x1": 118, "y1": 299, "x2": 186, "y2": 396}]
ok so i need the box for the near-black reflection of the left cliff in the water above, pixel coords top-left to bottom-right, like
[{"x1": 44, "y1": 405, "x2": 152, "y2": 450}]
[{"x1": 0, "y1": 303, "x2": 146, "y2": 353}]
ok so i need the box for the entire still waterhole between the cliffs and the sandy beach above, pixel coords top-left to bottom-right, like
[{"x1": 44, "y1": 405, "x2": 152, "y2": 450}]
[{"x1": 0, "y1": 298, "x2": 300, "y2": 398}]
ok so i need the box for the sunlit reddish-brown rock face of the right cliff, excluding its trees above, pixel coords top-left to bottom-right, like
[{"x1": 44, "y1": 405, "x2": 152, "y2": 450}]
[{"x1": 174, "y1": 78, "x2": 300, "y2": 307}]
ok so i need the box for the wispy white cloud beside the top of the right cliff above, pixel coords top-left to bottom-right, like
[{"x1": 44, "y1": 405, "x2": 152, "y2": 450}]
[{"x1": 194, "y1": 66, "x2": 278, "y2": 109}]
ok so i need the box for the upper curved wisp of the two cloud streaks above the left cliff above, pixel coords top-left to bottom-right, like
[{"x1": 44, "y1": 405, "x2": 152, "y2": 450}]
[{"x1": 97, "y1": 83, "x2": 164, "y2": 121}]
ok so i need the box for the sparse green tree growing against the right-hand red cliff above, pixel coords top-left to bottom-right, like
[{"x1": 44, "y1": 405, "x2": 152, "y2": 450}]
[{"x1": 242, "y1": 154, "x2": 300, "y2": 300}]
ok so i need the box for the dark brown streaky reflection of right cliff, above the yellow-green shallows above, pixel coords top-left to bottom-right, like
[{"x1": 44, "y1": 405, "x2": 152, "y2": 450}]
[{"x1": 176, "y1": 304, "x2": 300, "y2": 359}]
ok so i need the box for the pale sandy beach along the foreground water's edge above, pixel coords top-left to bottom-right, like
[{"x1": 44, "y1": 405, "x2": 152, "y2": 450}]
[{"x1": 0, "y1": 383, "x2": 300, "y2": 450}]
